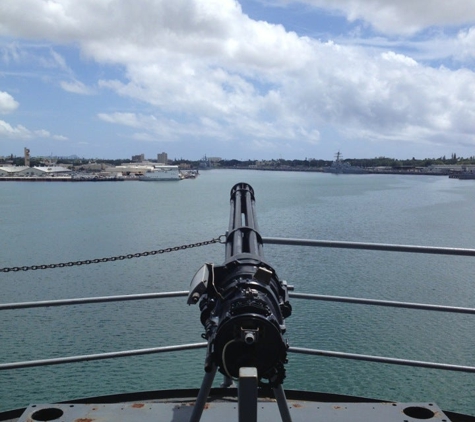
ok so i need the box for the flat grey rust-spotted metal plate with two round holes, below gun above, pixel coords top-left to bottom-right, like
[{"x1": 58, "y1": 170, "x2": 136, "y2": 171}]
[{"x1": 18, "y1": 400, "x2": 450, "y2": 422}]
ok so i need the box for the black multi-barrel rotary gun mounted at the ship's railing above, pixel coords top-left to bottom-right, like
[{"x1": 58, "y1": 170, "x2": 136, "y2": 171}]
[{"x1": 188, "y1": 183, "x2": 292, "y2": 420}]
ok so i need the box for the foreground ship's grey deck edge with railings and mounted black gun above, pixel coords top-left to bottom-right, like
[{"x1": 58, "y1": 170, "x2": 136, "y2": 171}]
[{"x1": 0, "y1": 183, "x2": 475, "y2": 422}]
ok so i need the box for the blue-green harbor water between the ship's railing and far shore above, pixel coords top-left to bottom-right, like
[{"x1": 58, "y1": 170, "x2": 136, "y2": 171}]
[{"x1": 0, "y1": 170, "x2": 475, "y2": 415}]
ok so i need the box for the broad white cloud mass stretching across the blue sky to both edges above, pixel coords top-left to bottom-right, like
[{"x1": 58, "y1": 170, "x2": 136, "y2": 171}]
[{"x1": 0, "y1": 0, "x2": 475, "y2": 157}]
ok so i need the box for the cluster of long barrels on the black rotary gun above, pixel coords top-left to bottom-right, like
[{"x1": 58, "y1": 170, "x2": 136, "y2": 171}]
[{"x1": 225, "y1": 183, "x2": 263, "y2": 261}]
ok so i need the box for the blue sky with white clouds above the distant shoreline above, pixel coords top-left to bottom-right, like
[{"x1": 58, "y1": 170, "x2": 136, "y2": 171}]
[{"x1": 0, "y1": 0, "x2": 475, "y2": 160}]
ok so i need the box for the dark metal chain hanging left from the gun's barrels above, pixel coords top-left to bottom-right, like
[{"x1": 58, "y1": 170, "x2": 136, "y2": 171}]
[{"x1": 0, "y1": 235, "x2": 224, "y2": 273}]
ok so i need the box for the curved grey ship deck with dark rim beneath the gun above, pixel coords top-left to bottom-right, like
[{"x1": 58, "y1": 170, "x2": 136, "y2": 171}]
[{"x1": 0, "y1": 388, "x2": 475, "y2": 422}]
